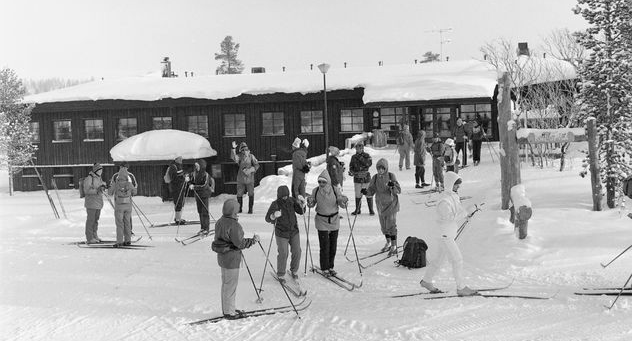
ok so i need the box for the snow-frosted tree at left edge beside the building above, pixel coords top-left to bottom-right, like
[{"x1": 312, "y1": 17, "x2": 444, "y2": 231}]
[{"x1": 0, "y1": 69, "x2": 37, "y2": 192}]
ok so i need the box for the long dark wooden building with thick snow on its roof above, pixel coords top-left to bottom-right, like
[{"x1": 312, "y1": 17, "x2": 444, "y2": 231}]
[{"x1": 21, "y1": 60, "x2": 498, "y2": 195}]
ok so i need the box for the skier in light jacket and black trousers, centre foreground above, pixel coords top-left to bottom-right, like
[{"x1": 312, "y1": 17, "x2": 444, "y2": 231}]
[{"x1": 307, "y1": 170, "x2": 349, "y2": 276}]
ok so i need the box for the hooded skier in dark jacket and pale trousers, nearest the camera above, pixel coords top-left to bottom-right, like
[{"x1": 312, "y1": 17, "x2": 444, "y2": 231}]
[{"x1": 211, "y1": 199, "x2": 260, "y2": 319}]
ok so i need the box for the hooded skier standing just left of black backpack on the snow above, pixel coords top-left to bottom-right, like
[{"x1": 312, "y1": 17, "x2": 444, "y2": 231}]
[{"x1": 363, "y1": 159, "x2": 402, "y2": 256}]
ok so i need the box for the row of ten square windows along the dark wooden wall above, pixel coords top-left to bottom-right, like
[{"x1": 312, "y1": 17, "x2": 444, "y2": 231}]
[{"x1": 31, "y1": 109, "x2": 364, "y2": 143}]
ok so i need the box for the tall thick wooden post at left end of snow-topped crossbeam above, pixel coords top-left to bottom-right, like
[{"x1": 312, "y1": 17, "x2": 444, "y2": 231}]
[{"x1": 497, "y1": 72, "x2": 520, "y2": 210}]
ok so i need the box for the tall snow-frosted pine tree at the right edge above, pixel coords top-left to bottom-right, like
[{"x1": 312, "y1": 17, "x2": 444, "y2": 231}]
[{"x1": 573, "y1": 0, "x2": 632, "y2": 208}]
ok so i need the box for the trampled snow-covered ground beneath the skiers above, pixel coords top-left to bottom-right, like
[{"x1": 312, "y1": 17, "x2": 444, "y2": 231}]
[{"x1": 0, "y1": 145, "x2": 632, "y2": 341}]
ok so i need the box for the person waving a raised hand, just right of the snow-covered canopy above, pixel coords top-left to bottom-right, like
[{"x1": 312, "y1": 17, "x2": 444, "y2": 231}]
[{"x1": 230, "y1": 141, "x2": 259, "y2": 214}]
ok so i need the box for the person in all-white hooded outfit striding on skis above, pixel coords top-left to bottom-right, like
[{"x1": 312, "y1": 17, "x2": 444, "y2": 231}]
[{"x1": 419, "y1": 172, "x2": 478, "y2": 296}]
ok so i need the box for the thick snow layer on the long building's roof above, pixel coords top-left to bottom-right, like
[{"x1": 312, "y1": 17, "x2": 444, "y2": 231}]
[{"x1": 24, "y1": 60, "x2": 497, "y2": 103}]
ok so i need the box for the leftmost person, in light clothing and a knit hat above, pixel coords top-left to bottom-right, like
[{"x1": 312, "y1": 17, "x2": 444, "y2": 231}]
[{"x1": 81, "y1": 163, "x2": 106, "y2": 244}]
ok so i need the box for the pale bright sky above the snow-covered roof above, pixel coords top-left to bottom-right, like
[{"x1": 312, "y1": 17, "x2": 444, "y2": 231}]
[{"x1": 0, "y1": 0, "x2": 586, "y2": 79}]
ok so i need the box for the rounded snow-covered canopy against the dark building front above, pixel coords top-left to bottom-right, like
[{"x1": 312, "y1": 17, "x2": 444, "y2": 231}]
[{"x1": 110, "y1": 129, "x2": 217, "y2": 162}]
